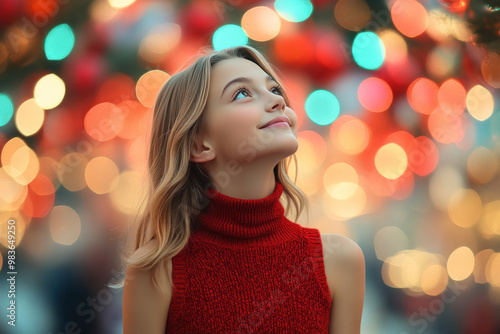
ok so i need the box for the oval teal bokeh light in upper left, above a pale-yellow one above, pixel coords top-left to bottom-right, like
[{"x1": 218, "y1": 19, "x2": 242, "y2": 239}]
[{"x1": 44, "y1": 23, "x2": 75, "y2": 60}]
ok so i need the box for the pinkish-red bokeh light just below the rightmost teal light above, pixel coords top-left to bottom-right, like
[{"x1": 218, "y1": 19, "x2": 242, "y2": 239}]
[{"x1": 358, "y1": 77, "x2": 393, "y2": 112}]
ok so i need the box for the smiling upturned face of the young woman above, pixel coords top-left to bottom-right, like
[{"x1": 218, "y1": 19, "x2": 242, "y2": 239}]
[{"x1": 199, "y1": 58, "x2": 298, "y2": 163}]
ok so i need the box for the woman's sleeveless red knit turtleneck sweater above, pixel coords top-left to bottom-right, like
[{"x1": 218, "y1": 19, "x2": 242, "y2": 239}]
[{"x1": 167, "y1": 182, "x2": 331, "y2": 334}]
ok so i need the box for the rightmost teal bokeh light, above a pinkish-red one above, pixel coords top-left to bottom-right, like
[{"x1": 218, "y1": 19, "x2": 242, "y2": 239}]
[{"x1": 352, "y1": 31, "x2": 385, "y2": 70}]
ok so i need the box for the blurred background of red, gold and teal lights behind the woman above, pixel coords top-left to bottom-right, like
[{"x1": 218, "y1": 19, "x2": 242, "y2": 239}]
[{"x1": 0, "y1": 0, "x2": 500, "y2": 334}]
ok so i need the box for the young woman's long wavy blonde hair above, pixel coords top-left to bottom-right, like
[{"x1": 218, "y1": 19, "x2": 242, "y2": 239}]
[{"x1": 115, "y1": 46, "x2": 308, "y2": 289}]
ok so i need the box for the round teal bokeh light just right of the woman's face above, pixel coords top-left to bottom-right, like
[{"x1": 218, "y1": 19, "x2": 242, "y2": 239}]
[{"x1": 305, "y1": 89, "x2": 340, "y2": 125}]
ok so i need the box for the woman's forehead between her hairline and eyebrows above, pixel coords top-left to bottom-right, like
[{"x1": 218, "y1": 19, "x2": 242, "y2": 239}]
[{"x1": 210, "y1": 58, "x2": 268, "y2": 90}]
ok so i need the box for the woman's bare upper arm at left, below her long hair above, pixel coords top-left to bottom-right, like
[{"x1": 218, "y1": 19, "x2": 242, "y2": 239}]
[{"x1": 123, "y1": 241, "x2": 172, "y2": 334}]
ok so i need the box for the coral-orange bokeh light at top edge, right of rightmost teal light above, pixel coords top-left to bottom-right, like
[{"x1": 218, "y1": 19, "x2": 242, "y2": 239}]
[{"x1": 391, "y1": 0, "x2": 428, "y2": 37}]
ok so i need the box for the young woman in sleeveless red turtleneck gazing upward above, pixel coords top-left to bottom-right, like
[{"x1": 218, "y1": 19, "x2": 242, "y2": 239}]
[{"x1": 123, "y1": 46, "x2": 365, "y2": 334}]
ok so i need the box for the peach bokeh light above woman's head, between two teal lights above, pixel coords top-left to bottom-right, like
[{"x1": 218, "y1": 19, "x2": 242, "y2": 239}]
[{"x1": 241, "y1": 6, "x2": 281, "y2": 42}]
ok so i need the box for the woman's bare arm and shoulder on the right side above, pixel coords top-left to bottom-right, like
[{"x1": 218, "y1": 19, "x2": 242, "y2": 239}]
[{"x1": 325, "y1": 235, "x2": 365, "y2": 334}]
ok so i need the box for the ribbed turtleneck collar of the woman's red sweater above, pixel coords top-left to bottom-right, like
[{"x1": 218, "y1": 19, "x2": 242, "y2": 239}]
[{"x1": 191, "y1": 181, "x2": 300, "y2": 246}]
